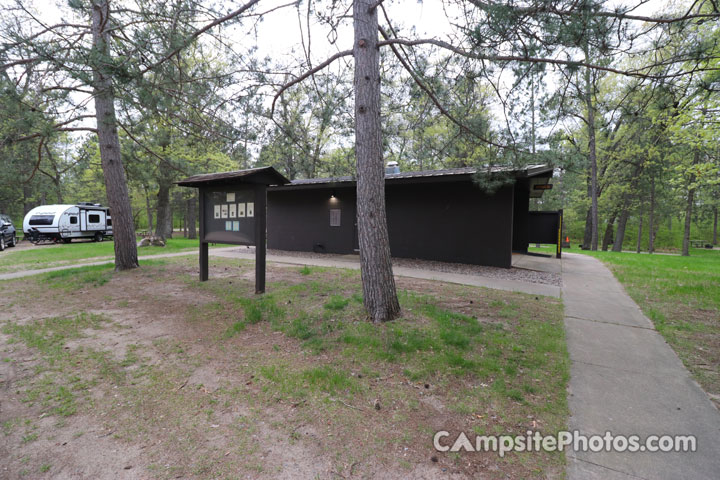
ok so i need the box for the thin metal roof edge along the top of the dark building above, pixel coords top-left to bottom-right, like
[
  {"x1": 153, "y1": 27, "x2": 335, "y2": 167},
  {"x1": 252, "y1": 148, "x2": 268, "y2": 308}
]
[{"x1": 274, "y1": 164, "x2": 553, "y2": 188}]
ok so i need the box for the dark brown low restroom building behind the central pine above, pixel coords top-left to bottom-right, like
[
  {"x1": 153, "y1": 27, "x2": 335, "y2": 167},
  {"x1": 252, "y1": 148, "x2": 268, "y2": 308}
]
[{"x1": 267, "y1": 165, "x2": 557, "y2": 268}]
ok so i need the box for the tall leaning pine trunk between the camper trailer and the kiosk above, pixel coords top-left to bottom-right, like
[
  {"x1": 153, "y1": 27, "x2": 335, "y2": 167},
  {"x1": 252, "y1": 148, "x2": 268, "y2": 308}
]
[{"x1": 90, "y1": 0, "x2": 138, "y2": 270}]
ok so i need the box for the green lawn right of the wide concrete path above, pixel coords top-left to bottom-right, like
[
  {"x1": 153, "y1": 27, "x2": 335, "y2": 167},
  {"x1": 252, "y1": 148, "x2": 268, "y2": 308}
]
[{"x1": 582, "y1": 248, "x2": 720, "y2": 402}]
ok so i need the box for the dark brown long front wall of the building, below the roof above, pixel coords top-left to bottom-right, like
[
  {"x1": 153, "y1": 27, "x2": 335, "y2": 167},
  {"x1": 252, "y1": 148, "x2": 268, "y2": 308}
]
[{"x1": 267, "y1": 181, "x2": 516, "y2": 268}]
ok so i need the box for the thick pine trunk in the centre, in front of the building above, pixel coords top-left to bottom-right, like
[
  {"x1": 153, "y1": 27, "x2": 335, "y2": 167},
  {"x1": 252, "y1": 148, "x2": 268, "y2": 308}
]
[{"x1": 353, "y1": 0, "x2": 400, "y2": 322}]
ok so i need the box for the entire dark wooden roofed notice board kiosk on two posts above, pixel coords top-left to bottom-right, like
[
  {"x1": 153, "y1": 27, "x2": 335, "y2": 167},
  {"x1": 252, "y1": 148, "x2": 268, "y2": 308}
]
[{"x1": 177, "y1": 167, "x2": 290, "y2": 293}]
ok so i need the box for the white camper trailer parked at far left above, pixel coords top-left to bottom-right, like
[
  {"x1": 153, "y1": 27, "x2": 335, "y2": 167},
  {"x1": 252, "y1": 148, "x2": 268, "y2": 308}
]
[{"x1": 23, "y1": 202, "x2": 112, "y2": 243}]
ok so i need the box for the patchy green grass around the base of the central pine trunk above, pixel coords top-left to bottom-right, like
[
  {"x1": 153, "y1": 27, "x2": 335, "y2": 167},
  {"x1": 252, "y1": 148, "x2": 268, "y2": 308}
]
[{"x1": 210, "y1": 272, "x2": 569, "y2": 412}]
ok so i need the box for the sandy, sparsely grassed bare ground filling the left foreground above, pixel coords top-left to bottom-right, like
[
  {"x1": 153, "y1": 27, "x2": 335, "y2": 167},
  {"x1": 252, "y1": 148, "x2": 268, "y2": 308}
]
[{"x1": 0, "y1": 258, "x2": 565, "y2": 479}]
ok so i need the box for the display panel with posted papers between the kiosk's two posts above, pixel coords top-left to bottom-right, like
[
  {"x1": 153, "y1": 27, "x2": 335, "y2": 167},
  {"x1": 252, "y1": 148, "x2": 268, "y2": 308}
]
[{"x1": 202, "y1": 185, "x2": 255, "y2": 245}]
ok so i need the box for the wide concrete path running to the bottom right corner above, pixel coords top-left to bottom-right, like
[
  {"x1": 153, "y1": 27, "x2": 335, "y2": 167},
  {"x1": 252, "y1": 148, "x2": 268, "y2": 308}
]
[{"x1": 562, "y1": 254, "x2": 720, "y2": 480}]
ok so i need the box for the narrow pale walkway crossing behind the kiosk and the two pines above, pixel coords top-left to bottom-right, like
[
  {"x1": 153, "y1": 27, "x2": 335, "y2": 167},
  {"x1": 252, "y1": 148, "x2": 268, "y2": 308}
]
[{"x1": 0, "y1": 247, "x2": 560, "y2": 298}]
